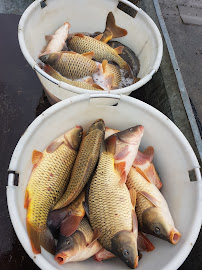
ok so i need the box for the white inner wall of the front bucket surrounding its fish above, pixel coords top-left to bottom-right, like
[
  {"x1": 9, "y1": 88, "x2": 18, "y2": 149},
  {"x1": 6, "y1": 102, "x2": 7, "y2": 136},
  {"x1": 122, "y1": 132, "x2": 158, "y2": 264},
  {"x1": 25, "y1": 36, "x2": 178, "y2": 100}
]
[{"x1": 10, "y1": 97, "x2": 199, "y2": 270}]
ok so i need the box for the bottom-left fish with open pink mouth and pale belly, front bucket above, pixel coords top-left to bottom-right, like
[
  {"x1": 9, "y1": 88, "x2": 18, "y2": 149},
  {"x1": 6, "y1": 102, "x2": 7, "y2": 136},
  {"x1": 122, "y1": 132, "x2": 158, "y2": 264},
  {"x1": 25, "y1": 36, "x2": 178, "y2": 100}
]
[{"x1": 55, "y1": 217, "x2": 102, "y2": 265}]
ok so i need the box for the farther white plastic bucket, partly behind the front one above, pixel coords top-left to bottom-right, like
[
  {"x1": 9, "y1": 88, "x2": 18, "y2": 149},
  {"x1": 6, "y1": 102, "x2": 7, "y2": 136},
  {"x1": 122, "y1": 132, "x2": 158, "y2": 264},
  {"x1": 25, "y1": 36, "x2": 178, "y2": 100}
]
[{"x1": 18, "y1": 0, "x2": 163, "y2": 104}]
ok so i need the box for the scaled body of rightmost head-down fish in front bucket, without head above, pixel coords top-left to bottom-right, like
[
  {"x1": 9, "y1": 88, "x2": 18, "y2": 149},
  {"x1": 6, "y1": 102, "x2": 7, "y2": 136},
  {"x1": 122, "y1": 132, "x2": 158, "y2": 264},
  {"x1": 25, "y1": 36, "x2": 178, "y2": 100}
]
[{"x1": 126, "y1": 167, "x2": 174, "y2": 227}]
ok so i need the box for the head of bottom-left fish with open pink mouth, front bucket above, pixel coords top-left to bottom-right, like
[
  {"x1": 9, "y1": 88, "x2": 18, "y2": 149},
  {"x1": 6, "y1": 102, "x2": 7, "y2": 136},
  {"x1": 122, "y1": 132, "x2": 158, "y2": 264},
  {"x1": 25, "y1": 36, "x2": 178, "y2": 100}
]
[{"x1": 55, "y1": 231, "x2": 86, "y2": 264}]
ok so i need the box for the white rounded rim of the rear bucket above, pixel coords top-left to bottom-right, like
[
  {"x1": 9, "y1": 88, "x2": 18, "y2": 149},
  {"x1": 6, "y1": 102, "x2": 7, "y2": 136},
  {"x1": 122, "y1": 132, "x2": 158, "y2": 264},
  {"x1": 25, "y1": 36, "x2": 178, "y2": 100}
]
[{"x1": 18, "y1": 0, "x2": 163, "y2": 95}]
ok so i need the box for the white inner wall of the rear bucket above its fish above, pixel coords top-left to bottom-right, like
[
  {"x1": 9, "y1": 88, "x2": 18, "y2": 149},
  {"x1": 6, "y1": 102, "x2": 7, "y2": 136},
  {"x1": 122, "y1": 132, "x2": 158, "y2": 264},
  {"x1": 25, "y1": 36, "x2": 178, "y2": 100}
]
[{"x1": 23, "y1": 0, "x2": 158, "y2": 78}]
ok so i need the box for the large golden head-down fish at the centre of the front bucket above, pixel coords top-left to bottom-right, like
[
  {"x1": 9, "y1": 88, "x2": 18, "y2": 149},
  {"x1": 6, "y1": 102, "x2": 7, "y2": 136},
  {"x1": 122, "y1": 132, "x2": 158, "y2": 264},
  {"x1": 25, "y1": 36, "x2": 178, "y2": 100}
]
[{"x1": 85, "y1": 152, "x2": 138, "y2": 269}]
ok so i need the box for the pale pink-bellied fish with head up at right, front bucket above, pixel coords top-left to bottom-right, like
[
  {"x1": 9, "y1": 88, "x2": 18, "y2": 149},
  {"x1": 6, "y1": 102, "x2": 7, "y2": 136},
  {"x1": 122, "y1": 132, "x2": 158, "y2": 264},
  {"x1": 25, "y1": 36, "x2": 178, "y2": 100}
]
[{"x1": 105, "y1": 125, "x2": 144, "y2": 183}]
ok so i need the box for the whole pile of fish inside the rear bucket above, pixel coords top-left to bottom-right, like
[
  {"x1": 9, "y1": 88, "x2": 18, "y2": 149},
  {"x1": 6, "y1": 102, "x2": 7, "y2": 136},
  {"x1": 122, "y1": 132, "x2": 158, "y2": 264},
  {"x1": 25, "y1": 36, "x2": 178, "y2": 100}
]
[{"x1": 39, "y1": 12, "x2": 139, "y2": 90}]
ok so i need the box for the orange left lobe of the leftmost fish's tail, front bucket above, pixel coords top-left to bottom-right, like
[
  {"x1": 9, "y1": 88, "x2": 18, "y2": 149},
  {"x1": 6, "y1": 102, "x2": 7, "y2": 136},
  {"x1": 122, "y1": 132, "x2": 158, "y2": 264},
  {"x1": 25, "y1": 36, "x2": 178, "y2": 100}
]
[{"x1": 26, "y1": 219, "x2": 41, "y2": 254}]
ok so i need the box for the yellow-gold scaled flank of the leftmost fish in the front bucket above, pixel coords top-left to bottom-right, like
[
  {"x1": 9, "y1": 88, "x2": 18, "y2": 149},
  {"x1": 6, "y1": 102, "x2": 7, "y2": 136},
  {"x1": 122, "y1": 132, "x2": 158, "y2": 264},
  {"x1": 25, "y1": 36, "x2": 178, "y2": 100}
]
[{"x1": 25, "y1": 143, "x2": 77, "y2": 231}]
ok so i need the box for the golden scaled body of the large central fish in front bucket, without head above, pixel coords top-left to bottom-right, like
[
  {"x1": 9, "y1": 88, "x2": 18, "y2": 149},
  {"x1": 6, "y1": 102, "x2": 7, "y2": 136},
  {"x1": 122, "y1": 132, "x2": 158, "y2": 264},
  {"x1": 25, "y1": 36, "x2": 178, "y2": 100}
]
[{"x1": 88, "y1": 152, "x2": 133, "y2": 251}]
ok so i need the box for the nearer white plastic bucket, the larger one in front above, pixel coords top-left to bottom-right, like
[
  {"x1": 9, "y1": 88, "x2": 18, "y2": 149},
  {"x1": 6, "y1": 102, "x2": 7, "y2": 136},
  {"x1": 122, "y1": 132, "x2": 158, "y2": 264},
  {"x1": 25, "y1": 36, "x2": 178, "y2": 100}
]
[{"x1": 7, "y1": 94, "x2": 202, "y2": 270}]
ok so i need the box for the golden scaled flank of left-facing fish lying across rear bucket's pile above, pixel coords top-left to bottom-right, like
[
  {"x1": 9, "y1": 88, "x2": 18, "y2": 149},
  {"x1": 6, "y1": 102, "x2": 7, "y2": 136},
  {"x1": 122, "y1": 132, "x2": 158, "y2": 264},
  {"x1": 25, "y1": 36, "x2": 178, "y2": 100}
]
[{"x1": 51, "y1": 52, "x2": 98, "y2": 79}]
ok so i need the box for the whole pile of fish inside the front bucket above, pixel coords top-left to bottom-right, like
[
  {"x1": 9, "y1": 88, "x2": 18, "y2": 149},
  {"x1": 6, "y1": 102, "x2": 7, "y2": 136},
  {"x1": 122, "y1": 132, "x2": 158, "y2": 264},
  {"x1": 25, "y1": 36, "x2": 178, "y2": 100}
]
[{"x1": 24, "y1": 119, "x2": 181, "y2": 269}]
